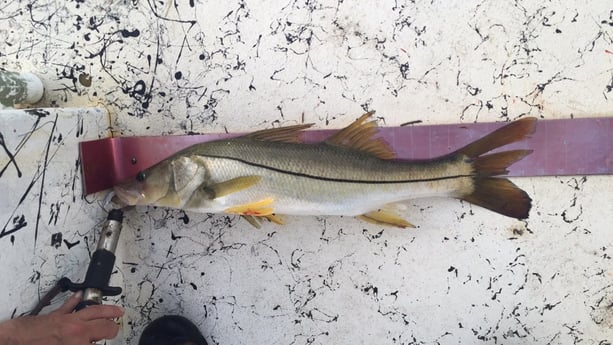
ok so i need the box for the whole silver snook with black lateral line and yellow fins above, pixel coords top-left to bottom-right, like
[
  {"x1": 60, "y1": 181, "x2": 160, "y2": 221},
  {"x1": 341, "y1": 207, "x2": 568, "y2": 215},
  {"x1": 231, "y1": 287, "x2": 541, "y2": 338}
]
[{"x1": 114, "y1": 113, "x2": 536, "y2": 227}]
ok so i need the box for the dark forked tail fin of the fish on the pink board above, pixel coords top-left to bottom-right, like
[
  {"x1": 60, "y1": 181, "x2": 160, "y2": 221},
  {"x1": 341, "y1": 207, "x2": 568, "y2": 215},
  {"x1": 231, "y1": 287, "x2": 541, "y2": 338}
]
[{"x1": 455, "y1": 117, "x2": 536, "y2": 219}]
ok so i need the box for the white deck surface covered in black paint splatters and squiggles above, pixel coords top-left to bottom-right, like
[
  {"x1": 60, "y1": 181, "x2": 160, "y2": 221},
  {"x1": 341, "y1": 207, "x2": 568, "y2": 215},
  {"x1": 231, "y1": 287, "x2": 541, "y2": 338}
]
[{"x1": 0, "y1": 0, "x2": 613, "y2": 345}]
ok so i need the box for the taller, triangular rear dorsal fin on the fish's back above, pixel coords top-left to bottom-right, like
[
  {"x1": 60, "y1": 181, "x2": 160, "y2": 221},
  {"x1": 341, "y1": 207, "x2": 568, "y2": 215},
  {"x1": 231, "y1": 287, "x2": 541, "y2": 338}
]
[{"x1": 326, "y1": 111, "x2": 396, "y2": 159}]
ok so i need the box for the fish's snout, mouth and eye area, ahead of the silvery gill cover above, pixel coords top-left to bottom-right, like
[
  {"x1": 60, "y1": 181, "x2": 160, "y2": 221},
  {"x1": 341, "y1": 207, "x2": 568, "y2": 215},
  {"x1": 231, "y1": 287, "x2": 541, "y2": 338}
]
[{"x1": 113, "y1": 161, "x2": 172, "y2": 205}]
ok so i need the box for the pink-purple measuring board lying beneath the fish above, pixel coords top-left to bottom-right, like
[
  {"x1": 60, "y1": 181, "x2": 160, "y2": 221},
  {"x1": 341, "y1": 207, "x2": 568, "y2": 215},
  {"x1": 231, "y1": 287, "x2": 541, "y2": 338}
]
[{"x1": 79, "y1": 118, "x2": 613, "y2": 194}]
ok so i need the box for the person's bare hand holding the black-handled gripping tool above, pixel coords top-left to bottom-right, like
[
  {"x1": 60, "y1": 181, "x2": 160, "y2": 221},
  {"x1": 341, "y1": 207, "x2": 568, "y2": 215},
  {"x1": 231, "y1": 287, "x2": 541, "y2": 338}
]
[{"x1": 0, "y1": 293, "x2": 124, "y2": 345}]
